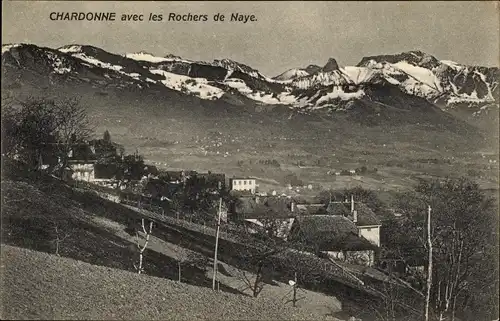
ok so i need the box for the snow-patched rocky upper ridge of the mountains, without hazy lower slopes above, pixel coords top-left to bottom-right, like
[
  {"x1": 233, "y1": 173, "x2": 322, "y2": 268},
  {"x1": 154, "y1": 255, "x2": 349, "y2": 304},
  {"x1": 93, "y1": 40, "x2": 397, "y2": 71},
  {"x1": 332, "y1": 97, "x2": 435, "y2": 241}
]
[{"x1": 2, "y1": 44, "x2": 500, "y2": 119}]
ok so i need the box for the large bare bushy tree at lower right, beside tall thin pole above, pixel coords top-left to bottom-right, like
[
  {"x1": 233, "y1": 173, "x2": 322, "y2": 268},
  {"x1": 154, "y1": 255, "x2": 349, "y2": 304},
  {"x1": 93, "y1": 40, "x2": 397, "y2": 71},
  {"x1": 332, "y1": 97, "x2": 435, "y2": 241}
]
[{"x1": 397, "y1": 178, "x2": 498, "y2": 320}]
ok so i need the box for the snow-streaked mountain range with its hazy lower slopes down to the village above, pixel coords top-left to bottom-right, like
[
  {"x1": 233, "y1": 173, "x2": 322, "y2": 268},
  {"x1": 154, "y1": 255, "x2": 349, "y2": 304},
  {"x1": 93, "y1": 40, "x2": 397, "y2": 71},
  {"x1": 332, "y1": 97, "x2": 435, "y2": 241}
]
[{"x1": 2, "y1": 44, "x2": 499, "y2": 190}]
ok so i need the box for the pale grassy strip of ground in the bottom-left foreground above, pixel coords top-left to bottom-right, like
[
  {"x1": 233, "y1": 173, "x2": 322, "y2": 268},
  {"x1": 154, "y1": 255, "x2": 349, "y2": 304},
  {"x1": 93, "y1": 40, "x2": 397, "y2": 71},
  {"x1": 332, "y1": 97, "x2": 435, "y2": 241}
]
[{"x1": 0, "y1": 245, "x2": 344, "y2": 320}]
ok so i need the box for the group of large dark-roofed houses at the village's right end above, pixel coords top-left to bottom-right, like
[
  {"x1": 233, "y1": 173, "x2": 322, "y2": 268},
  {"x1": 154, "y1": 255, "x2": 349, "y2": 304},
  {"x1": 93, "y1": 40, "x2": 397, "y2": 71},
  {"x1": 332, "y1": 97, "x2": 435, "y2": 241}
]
[{"x1": 228, "y1": 189, "x2": 382, "y2": 266}]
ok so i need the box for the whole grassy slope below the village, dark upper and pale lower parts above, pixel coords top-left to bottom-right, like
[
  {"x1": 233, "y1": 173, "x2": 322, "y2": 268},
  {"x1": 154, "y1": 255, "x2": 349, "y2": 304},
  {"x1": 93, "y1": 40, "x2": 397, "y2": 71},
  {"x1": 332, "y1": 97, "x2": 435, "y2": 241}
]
[{"x1": 0, "y1": 162, "x2": 357, "y2": 320}]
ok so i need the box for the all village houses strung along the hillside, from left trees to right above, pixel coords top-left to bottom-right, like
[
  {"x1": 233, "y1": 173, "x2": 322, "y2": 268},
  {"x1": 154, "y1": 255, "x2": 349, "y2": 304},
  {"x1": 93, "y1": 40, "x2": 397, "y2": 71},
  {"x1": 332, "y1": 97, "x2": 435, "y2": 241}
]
[{"x1": 39, "y1": 140, "x2": 381, "y2": 266}]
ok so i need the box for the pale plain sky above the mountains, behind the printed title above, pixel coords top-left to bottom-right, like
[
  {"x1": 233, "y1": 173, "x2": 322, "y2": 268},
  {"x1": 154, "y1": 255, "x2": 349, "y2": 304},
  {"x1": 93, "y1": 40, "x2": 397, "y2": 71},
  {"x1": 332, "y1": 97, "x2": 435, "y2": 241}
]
[{"x1": 2, "y1": 1, "x2": 500, "y2": 76}]
